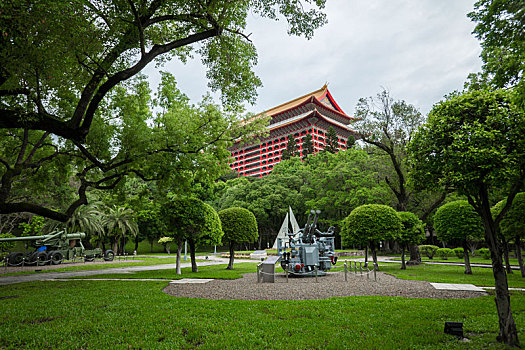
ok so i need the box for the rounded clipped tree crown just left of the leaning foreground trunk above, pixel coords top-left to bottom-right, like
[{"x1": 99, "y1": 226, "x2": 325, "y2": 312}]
[{"x1": 434, "y1": 201, "x2": 484, "y2": 244}]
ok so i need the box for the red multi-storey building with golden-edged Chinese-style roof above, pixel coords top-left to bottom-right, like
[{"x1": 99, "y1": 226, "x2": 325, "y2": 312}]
[{"x1": 230, "y1": 85, "x2": 355, "y2": 177}]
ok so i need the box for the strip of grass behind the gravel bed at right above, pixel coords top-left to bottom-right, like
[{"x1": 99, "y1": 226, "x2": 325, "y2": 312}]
[{"x1": 380, "y1": 264, "x2": 525, "y2": 288}]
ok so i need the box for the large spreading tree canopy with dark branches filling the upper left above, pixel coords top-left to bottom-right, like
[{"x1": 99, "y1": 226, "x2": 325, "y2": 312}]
[{"x1": 0, "y1": 0, "x2": 326, "y2": 221}]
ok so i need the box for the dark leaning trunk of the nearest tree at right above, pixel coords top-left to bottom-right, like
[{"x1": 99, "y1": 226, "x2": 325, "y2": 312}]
[{"x1": 476, "y1": 187, "x2": 519, "y2": 347}]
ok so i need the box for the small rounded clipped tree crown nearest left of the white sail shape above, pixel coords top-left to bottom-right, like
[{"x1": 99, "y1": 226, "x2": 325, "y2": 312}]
[{"x1": 219, "y1": 207, "x2": 259, "y2": 243}]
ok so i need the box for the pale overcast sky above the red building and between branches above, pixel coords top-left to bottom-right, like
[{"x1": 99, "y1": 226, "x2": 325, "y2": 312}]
[{"x1": 146, "y1": 0, "x2": 481, "y2": 115}]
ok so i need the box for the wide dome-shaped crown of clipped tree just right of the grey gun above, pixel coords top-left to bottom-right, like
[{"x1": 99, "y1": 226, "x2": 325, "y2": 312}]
[{"x1": 341, "y1": 204, "x2": 403, "y2": 246}]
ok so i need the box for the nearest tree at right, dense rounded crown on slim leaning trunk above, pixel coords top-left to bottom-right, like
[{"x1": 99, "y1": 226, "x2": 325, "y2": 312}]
[{"x1": 408, "y1": 90, "x2": 525, "y2": 345}]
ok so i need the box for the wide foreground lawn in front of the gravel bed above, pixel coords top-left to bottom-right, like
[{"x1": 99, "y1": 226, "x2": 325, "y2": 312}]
[{"x1": 0, "y1": 281, "x2": 525, "y2": 349}]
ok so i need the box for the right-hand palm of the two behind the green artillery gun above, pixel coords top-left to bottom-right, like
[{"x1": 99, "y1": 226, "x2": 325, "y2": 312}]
[{"x1": 102, "y1": 205, "x2": 139, "y2": 254}]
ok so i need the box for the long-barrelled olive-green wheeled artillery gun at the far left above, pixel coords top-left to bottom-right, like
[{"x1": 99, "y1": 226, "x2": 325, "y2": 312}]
[{"x1": 0, "y1": 231, "x2": 115, "y2": 266}]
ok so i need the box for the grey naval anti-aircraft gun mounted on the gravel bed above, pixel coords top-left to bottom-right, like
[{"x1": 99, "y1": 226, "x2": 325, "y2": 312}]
[{"x1": 277, "y1": 210, "x2": 337, "y2": 276}]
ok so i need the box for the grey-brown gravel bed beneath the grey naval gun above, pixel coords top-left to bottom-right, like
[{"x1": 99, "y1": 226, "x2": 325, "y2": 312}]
[{"x1": 164, "y1": 272, "x2": 487, "y2": 300}]
